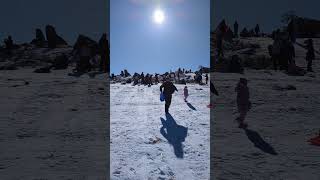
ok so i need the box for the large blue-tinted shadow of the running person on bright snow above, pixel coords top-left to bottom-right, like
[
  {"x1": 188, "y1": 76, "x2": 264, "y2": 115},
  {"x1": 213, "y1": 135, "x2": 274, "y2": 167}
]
[{"x1": 160, "y1": 113, "x2": 188, "y2": 158}]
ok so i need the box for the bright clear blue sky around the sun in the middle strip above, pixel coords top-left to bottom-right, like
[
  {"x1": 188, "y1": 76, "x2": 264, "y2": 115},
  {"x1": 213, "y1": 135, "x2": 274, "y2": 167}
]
[{"x1": 110, "y1": 0, "x2": 210, "y2": 74}]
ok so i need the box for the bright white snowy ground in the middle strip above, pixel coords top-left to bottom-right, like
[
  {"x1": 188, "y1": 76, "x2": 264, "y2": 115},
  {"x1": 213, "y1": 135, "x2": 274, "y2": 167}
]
[{"x1": 110, "y1": 84, "x2": 210, "y2": 180}]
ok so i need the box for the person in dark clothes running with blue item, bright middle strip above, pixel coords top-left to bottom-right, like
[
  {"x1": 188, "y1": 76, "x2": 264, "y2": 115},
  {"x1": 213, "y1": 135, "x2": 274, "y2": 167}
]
[{"x1": 160, "y1": 79, "x2": 178, "y2": 113}]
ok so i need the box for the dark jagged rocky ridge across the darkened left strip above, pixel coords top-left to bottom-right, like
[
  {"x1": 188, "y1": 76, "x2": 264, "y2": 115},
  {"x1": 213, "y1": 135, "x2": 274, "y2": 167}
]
[{"x1": 0, "y1": 25, "x2": 110, "y2": 74}]
